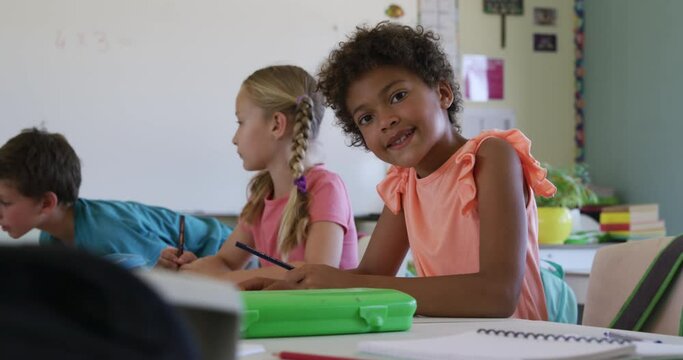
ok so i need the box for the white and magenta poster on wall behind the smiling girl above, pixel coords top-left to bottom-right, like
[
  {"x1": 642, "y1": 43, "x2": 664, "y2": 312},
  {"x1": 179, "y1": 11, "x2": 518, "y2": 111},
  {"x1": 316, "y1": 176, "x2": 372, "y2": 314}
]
[{"x1": 462, "y1": 54, "x2": 505, "y2": 101}]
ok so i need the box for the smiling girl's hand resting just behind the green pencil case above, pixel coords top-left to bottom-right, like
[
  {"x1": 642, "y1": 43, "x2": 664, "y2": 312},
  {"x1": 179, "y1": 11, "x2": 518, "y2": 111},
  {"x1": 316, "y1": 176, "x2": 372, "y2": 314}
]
[{"x1": 239, "y1": 264, "x2": 357, "y2": 290}]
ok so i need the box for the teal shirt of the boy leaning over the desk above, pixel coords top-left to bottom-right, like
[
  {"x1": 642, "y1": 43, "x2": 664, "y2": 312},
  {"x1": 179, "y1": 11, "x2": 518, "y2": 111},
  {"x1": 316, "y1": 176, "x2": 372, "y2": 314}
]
[{"x1": 40, "y1": 199, "x2": 232, "y2": 266}]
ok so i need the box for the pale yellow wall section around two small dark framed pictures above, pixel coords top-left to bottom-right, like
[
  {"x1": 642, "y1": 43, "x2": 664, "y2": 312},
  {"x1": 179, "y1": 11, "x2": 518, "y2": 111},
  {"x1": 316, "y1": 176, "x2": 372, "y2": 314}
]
[{"x1": 459, "y1": 0, "x2": 574, "y2": 166}]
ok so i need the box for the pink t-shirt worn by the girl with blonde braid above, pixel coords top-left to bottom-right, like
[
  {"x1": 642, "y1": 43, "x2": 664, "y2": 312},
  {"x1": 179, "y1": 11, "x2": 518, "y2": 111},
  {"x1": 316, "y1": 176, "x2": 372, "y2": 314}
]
[{"x1": 237, "y1": 165, "x2": 358, "y2": 269}]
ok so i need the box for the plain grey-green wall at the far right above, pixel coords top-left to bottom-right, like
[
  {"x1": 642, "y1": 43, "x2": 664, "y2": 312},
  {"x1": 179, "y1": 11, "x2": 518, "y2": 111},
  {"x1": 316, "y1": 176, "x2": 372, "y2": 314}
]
[{"x1": 585, "y1": 0, "x2": 683, "y2": 235}]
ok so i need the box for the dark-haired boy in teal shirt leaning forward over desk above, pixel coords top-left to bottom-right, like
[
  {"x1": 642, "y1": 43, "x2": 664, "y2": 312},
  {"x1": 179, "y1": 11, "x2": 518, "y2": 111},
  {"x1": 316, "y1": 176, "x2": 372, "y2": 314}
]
[{"x1": 0, "y1": 128, "x2": 232, "y2": 269}]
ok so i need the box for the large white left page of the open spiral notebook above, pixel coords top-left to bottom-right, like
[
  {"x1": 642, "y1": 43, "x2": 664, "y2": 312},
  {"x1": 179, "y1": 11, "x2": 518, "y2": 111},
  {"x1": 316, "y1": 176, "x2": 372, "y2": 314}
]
[{"x1": 358, "y1": 331, "x2": 635, "y2": 360}]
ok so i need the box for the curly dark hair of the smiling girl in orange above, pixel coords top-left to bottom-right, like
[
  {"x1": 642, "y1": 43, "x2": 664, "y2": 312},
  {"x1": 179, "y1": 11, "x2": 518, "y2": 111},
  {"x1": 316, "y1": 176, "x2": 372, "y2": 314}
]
[{"x1": 318, "y1": 21, "x2": 462, "y2": 149}]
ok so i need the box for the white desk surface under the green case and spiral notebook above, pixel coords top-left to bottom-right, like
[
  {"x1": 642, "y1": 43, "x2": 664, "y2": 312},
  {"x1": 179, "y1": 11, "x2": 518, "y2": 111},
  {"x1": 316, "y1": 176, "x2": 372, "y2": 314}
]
[{"x1": 239, "y1": 318, "x2": 683, "y2": 360}]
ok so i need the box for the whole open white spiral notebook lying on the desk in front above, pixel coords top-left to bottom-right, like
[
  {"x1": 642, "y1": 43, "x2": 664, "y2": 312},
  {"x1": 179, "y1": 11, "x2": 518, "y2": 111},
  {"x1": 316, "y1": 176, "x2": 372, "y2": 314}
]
[{"x1": 358, "y1": 329, "x2": 683, "y2": 360}]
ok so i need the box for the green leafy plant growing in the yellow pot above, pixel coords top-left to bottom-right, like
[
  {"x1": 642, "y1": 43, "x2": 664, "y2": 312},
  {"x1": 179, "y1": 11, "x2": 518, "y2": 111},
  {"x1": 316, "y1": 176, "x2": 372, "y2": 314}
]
[{"x1": 536, "y1": 164, "x2": 598, "y2": 209}]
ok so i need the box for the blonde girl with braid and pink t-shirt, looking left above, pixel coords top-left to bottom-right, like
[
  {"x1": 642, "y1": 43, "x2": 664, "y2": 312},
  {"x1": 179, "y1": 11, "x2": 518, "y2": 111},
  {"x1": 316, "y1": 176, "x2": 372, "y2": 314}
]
[{"x1": 182, "y1": 66, "x2": 358, "y2": 282}]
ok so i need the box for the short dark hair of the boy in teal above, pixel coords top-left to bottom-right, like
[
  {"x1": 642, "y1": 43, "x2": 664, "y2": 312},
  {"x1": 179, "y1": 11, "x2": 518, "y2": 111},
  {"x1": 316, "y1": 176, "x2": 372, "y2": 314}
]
[{"x1": 0, "y1": 128, "x2": 81, "y2": 206}]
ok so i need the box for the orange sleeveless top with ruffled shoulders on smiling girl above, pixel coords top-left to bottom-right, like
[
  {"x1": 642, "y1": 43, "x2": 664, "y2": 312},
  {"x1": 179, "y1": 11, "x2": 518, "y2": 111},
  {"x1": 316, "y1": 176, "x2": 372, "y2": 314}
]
[{"x1": 377, "y1": 130, "x2": 555, "y2": 320}]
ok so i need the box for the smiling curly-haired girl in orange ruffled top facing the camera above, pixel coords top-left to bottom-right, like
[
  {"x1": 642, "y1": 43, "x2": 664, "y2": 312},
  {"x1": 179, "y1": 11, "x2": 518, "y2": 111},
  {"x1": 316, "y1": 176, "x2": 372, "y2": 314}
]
[{"x1": 242, "y1": 23, "x2": 555, "y2": 320}]
